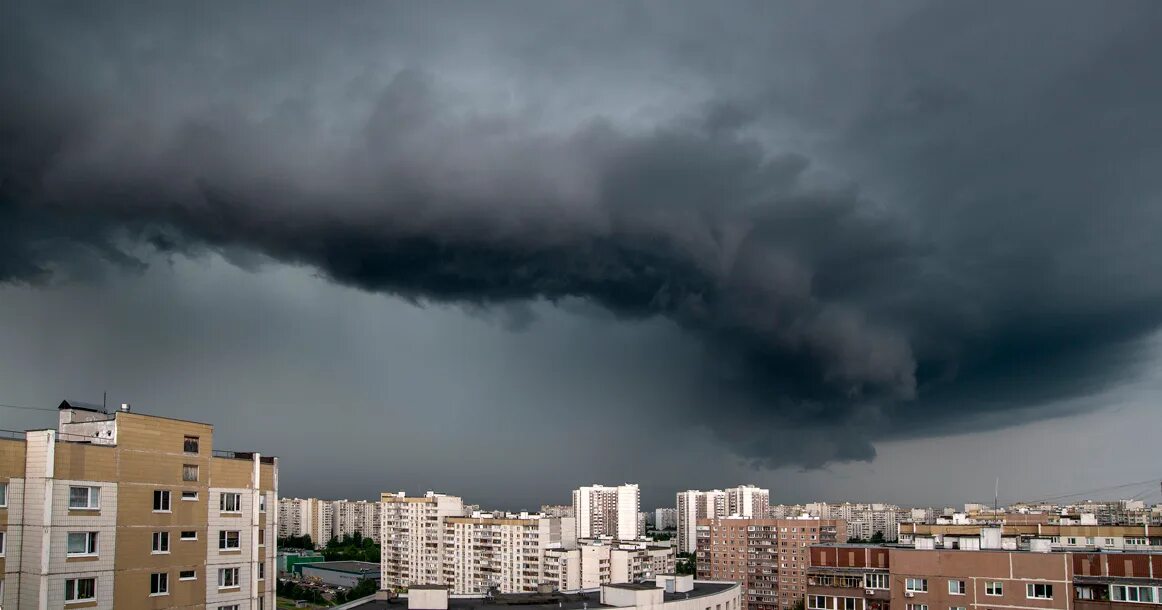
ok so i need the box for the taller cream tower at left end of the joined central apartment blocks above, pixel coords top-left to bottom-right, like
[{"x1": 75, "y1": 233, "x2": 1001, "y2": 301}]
[{"x1": 380, "y1": 491, "x2": 464, "y2": 589}]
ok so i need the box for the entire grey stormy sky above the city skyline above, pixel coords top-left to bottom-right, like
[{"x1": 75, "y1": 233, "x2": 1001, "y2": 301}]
[{"x1": 0, "y1": 0, "x2": 1162, "y2": 508}]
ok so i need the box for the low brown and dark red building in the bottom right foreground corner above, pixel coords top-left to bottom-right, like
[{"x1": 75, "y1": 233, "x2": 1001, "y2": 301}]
[{"x1": 805, "y1": 529, "x2": 1162, "y2": 610}]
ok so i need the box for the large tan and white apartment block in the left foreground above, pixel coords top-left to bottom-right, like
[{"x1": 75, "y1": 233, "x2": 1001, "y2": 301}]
[{"x1": 0, "y1": 401, "x2": 278, "y2": 610}]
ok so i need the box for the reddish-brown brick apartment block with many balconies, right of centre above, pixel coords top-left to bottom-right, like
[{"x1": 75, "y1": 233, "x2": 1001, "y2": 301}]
[{"x1": 697, "y1": 517, "x2": 849, "y2": 610}]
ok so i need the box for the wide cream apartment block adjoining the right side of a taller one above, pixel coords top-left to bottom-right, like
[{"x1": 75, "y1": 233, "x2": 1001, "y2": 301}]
[{"x1": 442, "y1": 512, "x2": 575, "y2": 594}]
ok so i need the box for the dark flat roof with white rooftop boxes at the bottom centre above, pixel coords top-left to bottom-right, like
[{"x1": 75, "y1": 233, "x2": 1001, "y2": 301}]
[{"x1": 348, "y1": 580, "x2": 740, "y2": 610}]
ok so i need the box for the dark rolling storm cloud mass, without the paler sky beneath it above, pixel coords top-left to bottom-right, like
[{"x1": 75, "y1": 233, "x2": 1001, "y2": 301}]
[{"x1": 0, "y1": 1, "x2": 1162, "y2": 466}]
